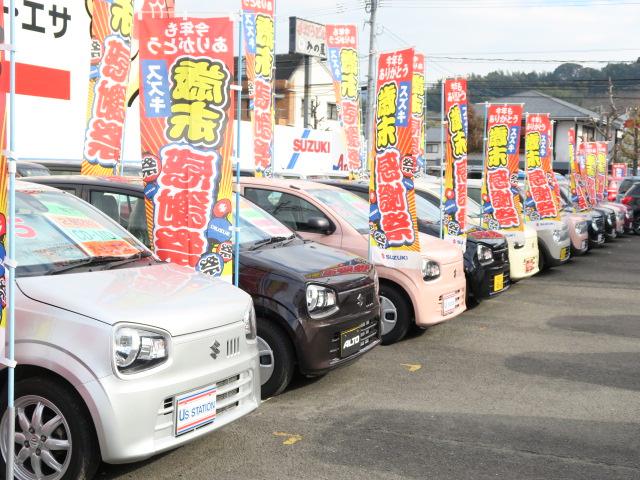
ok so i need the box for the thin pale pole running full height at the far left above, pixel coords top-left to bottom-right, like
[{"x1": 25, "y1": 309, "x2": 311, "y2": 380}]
[{"x1": 4, "y1": 0, "x2": 16, "y2": 479}]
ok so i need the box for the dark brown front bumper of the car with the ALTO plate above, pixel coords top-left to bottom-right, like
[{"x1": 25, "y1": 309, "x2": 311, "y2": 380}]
[{"x1": 296, "y1": 286, "x2": 381, "y2": 375}]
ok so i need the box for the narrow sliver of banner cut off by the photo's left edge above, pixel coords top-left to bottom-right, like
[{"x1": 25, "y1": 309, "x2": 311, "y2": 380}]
[{"x1": 0, "y1": 0, "x2": 9, "y2": 358}]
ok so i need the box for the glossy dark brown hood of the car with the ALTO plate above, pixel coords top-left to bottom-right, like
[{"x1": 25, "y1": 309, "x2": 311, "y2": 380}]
[{"x1": 240, "y1": 242, "x2": 373, "y2": 288}]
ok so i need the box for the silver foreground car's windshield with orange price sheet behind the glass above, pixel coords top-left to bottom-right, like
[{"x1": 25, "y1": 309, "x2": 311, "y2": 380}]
[{"x1": 16, "y1": 190, "x2": 146, "y2": 277}]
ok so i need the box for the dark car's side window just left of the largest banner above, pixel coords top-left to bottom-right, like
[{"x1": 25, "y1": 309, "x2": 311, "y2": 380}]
[{"x1": 90, "y1": 190, "x2": 149, "y2": 246}]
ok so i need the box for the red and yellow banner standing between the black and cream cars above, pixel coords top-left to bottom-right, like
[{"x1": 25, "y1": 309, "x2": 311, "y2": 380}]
[{"x1": 482, "y1": 104, "x2": 524, "y2": 232}]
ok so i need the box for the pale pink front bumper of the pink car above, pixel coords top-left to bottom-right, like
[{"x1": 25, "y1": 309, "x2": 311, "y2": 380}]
[{"x1": 413, "y1": 259, "x2": 467, "y2": 327}]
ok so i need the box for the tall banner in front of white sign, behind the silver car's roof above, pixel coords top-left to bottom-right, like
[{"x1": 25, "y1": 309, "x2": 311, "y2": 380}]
[{"x1": 81, "y1": 0, "x2": 133, "y2": 175}]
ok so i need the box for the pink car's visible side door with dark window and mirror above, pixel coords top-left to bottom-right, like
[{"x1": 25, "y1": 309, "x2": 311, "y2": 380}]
[{"x1": 243, "y1": 186, "x2": 342, "y2": 248}]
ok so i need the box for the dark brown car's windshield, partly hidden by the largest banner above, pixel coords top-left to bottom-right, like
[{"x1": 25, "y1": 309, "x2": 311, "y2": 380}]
[{"x1": 240, "y1": 197, "x2": 295, "y2": 248}]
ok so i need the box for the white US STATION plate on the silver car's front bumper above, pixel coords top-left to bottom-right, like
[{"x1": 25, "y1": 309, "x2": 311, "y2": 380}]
[{"x1": 175, "y1": 383, "x2": 217, "y2": 437}]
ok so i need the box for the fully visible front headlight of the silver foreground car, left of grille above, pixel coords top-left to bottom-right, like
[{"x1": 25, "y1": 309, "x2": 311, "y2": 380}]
[{"x1": 113, "y1": 326, "x2": 169, "y2": 374}]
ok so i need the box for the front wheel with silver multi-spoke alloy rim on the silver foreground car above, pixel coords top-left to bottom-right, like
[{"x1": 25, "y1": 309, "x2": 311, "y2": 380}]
[{"x1": 0, "y1": 377, "x2": 100, "y2": 480}]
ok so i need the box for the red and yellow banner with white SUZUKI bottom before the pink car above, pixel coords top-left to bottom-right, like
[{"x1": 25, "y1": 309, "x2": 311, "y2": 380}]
[{"x1": 369, "y1": 48, "x2": 421, "y2": 268}]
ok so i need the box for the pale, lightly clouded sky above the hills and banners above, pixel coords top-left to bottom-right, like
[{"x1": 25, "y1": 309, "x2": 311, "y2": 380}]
[{"x1": 176, "y1": 0, "x2": 640, "y2": 82}]
